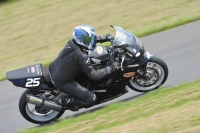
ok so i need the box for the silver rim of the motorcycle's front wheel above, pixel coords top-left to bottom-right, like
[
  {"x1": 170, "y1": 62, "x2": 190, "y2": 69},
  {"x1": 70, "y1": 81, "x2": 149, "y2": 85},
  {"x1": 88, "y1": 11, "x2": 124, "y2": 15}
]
[{"x1": 129, "y1": 62, "x2": 165, "y2": 91}]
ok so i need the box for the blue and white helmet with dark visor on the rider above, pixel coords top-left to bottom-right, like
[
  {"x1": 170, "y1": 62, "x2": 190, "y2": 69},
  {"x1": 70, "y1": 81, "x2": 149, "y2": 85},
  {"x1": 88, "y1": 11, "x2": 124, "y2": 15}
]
[{"x1": 73, "y1": 25, "x2": 96, "y2": 49}]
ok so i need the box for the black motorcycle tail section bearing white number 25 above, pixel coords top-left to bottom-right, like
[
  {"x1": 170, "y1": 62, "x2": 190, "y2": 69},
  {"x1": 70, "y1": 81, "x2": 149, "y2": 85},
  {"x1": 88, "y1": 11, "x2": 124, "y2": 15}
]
[{"x1": 6, "y1": 64, "x2": 54, "y2": 90}]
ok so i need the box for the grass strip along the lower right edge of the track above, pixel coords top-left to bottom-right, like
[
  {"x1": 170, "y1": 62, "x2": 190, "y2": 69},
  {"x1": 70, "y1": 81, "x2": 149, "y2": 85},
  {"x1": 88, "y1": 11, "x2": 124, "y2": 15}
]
[{"x1": 20, "y1": 79, "x2": 200, "y2": 133}]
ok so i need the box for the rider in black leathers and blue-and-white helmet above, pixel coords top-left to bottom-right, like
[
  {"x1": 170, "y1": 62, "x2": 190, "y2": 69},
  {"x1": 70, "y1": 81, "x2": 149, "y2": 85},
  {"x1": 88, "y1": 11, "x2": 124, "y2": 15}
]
[{"x1": 49, "y1": 25, "x2": 118, "y2": 111}]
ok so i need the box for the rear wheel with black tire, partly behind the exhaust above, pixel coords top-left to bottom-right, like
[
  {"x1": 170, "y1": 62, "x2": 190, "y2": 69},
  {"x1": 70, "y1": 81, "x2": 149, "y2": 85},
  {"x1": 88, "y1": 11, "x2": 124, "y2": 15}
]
[{"x1": 19, "y1": 90, "x2": 65, "y2": 124}]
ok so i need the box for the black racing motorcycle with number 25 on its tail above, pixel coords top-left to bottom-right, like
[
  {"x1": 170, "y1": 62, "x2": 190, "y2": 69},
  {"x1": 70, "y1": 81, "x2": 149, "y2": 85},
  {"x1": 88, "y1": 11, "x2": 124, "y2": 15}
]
[{"x1": 6, "y1": 26, "x2": 168, "y2": 124}]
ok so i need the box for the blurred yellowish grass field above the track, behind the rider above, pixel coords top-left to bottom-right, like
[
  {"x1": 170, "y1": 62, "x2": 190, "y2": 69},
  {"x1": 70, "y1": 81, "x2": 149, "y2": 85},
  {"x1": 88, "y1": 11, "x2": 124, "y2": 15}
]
[{"x1": 0, "y1": 0, "x2": 200, "y2": 80}]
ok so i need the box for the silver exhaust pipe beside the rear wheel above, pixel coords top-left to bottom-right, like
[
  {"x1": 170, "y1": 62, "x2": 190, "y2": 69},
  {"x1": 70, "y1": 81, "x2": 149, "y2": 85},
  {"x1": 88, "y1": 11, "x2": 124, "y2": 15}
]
[{"x1": 26, "y1": 95, "x2": 62, "y2": 112}]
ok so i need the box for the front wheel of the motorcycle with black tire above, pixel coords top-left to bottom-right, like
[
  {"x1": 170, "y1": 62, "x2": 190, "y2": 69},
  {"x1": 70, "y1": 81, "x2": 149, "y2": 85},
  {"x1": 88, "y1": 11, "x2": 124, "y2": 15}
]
[{"x1": 127, "y1": 56, "x2": 168, "y2": 92}]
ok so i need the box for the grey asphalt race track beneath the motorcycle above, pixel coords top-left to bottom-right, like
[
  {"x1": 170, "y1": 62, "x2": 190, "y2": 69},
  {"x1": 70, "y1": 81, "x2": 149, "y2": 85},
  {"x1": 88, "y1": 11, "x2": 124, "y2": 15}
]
[{"x1": 0, "y1": 21, "x2": 200, "y2": 133}]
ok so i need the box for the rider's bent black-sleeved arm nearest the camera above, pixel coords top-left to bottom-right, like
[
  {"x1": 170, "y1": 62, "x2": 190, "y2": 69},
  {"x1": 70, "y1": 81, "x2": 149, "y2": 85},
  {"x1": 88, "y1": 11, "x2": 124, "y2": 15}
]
[{"x1": 78, "y1": 53, "x2": 113, "y2": 80}]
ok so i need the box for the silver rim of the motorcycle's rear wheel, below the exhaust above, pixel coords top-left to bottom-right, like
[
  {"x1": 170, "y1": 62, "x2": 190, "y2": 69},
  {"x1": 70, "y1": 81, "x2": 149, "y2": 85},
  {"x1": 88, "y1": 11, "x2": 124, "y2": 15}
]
[{"x1": 25, "y1": 94, "x2": 59, "y2": 122}]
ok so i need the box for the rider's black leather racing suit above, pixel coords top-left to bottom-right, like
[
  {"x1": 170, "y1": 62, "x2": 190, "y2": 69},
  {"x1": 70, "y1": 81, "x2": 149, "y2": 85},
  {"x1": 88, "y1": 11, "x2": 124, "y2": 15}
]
[{"x1": 49, "y1": 37, "x2": 112, "y2": 107}]
